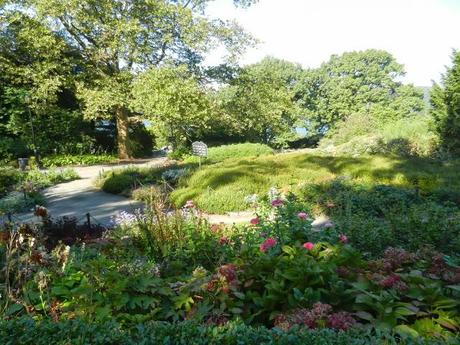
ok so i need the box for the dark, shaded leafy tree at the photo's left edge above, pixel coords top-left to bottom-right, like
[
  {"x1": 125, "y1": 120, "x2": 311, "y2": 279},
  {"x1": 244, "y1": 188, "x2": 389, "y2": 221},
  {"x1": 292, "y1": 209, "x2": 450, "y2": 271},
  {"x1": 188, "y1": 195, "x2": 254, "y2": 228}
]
[{"x1": 0, "y1": 10, "x2": 83, "y2": 158}]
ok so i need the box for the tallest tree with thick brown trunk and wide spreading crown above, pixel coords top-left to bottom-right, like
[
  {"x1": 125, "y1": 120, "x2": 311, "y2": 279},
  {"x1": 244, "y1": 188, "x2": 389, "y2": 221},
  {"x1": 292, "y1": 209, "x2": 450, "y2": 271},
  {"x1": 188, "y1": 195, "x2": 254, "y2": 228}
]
[{"x1": 6, "y1": 0, "x2": 252, "y2": 159}]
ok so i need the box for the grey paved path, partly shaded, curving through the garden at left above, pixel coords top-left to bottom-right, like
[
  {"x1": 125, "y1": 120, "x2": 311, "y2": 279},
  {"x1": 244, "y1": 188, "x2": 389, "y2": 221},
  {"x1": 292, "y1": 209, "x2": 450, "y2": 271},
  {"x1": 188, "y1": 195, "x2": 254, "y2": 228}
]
[{"x1": 12, "y1": 157, "x2": 166, "y2": 225}]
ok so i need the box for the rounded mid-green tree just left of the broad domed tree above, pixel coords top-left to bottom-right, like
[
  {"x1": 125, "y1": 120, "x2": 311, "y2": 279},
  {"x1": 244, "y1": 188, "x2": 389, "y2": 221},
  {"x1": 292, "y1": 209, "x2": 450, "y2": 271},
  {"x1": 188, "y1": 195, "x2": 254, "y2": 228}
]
[{"x1": 219, "y1": 57, "x2": 302, "y2": 145}]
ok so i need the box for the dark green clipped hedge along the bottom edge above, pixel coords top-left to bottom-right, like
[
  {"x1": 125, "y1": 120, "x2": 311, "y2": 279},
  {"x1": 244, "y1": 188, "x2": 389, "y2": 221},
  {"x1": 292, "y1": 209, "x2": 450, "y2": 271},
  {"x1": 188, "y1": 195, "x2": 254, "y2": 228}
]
[{"x1": 0, "y1": 318, "x2": 460, "y2": 345}]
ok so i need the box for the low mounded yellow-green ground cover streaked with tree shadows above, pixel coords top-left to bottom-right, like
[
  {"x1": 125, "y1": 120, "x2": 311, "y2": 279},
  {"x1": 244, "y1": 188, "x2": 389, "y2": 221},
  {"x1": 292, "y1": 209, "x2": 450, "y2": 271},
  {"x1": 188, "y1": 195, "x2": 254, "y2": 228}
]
[{"x1": 171, "y1": 153, "x2": 460, "y2": 213}]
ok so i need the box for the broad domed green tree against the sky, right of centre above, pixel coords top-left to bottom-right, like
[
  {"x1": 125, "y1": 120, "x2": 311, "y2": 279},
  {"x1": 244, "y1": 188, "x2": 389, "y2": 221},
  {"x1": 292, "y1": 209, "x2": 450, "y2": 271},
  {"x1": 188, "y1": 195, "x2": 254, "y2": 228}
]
[{"x1": 298, "y1": 49, "x2": 423, "y2": 133}]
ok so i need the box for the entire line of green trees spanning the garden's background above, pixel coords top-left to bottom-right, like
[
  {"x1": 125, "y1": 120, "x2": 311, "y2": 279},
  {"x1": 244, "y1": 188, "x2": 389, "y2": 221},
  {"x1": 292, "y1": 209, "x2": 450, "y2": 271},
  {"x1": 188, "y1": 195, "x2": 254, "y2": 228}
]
[{"x1": 0, "y1": 0, "x2": 460, "y2": 158}]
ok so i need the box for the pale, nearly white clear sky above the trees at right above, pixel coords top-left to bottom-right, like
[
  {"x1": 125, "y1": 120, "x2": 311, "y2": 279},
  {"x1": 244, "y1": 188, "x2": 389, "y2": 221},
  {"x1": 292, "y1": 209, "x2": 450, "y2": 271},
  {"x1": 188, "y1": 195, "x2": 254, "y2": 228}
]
[{"x1": 207, "y1": 0, "x2": 460, "y2": 86}]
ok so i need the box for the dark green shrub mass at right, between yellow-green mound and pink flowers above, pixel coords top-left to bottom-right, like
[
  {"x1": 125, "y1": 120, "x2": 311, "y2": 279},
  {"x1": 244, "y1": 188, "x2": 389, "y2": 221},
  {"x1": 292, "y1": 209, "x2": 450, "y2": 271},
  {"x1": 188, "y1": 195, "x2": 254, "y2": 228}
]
[{"x1": 302, "y1": 180, "x2": 460, "y2": 256}]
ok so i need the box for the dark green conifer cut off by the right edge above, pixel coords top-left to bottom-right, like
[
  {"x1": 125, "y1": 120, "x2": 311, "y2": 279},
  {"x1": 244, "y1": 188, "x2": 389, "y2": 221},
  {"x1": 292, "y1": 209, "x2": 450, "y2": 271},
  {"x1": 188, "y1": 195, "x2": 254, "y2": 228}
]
[{"x1": 430, "y1": 51, "x2": 460, "y2": 153}]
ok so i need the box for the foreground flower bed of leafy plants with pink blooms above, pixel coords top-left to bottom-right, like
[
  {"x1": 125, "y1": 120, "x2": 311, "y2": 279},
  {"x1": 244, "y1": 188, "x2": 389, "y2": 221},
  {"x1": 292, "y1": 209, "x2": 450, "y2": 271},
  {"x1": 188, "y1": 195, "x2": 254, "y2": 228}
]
[{"x1": 0, "y1": 189, "x2": 460, "y2": 343}]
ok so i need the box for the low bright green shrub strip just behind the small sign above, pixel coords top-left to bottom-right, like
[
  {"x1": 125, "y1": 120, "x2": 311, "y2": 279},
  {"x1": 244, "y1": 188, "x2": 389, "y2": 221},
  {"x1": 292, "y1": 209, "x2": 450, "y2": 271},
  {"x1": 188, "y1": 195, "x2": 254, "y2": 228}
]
[{"x1": 185, "y1": 143, "x2": 273, "y2": 163}]
